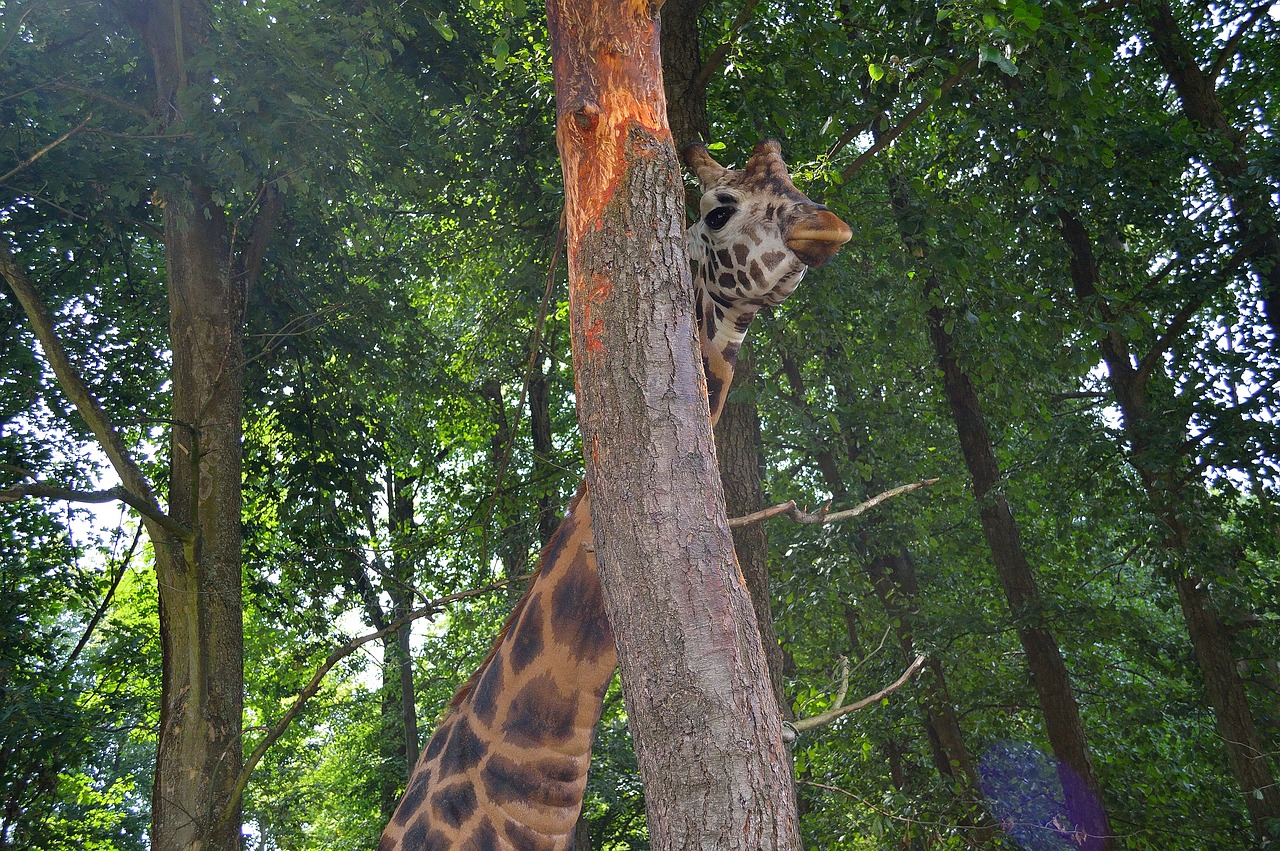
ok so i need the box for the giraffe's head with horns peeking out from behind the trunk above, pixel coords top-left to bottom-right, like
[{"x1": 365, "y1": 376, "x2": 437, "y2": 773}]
[{"x1": 684, "y1": 139, "x2": 852, "y2": 326}]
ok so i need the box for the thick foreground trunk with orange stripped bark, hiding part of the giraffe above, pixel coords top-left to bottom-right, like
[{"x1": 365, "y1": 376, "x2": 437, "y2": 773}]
[{"x1": 548, "y1": 0, "x2": 800, "y2": 851}]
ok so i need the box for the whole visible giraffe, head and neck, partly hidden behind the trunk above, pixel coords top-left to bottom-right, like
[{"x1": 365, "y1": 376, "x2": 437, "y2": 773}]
[{"x1": 378, "y1": 139, "x2": 851, "y2": 851}]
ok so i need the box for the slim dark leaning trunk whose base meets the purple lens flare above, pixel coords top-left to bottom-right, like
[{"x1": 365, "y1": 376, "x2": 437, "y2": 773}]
[{"x1": 890, "y1": 177, "x2": 1115, "y2": 851}]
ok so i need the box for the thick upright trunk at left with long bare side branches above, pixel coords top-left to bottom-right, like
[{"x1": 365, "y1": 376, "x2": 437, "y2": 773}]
[{"x1": 111, "y1": 3, "x2": 251, "y2": 851}]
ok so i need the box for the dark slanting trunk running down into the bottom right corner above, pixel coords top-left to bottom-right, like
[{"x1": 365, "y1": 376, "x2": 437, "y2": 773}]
[{"x1": 1059, "y1": 211, "x2": 1280, "y2": 839}]
